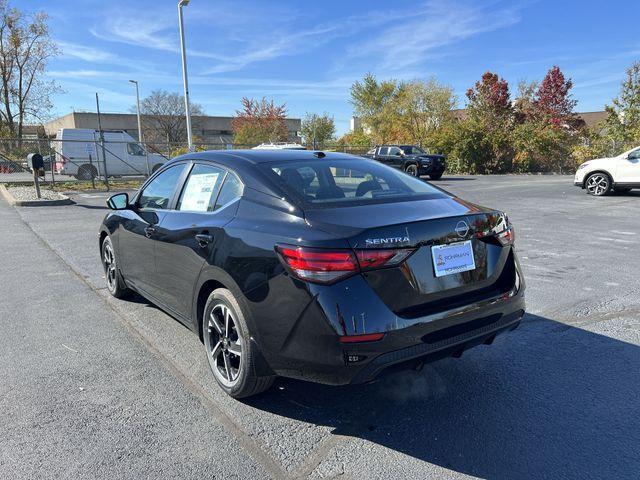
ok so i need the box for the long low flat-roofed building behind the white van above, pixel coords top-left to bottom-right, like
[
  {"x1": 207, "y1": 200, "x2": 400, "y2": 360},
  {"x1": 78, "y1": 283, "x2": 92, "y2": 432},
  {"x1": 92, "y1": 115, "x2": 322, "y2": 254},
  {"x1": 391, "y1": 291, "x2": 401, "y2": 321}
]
[{"x1": 44, "y1": 112, "x2": 302, "y2": 144}]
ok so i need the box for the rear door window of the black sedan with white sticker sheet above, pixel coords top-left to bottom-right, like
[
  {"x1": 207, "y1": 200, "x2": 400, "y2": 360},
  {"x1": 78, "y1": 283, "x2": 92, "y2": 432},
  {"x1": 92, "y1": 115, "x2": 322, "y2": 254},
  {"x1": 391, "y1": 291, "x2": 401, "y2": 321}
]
[{"x1": 177, "y1": 163, "x2": 224, "y2": 212}]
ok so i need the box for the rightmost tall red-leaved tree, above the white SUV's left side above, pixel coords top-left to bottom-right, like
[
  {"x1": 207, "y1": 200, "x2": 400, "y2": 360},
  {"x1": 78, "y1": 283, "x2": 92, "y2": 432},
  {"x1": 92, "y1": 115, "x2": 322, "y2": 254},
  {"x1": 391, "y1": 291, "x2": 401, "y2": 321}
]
[{"x1": 534, "y1": 65, "x2": 583, "y2": 128}]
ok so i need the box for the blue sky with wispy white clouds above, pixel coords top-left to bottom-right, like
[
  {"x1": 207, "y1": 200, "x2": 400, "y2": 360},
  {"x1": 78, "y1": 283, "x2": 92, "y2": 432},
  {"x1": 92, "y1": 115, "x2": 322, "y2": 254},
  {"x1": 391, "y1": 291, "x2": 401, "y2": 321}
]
[{"x1": 22, "y1": 0, "x2": 640, "y2": 133}]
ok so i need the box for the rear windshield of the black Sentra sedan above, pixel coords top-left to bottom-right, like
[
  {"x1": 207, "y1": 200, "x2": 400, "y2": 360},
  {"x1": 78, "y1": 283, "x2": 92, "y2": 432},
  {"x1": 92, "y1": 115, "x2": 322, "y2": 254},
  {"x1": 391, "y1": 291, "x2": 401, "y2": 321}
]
[{"x1": 263, "y1": 158, "x2": 445, "y2": 208}]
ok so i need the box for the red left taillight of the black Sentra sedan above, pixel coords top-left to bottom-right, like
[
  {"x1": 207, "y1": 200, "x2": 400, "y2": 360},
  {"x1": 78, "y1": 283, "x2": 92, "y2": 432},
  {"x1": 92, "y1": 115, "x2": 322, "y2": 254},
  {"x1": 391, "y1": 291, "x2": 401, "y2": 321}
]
[{"x1": 276, "y1": 245, "x2": 413, "y2": 283}]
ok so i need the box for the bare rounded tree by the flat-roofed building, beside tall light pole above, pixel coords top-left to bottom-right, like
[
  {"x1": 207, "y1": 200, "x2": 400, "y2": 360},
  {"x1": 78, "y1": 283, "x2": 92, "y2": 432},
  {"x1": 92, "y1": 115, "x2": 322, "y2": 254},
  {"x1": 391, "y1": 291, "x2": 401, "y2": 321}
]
[{"x1": 132, "y1": 90, "x2": 204, "y2": 143}]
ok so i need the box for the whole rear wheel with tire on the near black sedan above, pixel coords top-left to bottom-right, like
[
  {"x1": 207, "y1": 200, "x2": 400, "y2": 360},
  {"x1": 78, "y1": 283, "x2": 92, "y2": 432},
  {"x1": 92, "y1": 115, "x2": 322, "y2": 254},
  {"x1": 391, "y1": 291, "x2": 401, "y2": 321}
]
[{"x1": 201, "y1": 288, "x2": 275, "y2": 398}]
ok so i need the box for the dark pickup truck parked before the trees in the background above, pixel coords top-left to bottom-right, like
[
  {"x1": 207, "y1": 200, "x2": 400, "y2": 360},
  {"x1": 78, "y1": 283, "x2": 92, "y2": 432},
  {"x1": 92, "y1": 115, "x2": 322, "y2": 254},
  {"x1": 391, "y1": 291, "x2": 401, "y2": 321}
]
[{"x1": 363, "y1": 145, "x2": 446, "y2": 180}]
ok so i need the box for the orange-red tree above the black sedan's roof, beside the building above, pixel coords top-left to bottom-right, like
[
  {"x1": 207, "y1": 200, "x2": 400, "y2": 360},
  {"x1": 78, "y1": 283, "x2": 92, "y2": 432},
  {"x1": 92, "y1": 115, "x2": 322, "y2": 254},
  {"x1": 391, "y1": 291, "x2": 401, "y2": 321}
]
[{"x1": 231, "y1": 97, "x2": 289, "y2": 146}]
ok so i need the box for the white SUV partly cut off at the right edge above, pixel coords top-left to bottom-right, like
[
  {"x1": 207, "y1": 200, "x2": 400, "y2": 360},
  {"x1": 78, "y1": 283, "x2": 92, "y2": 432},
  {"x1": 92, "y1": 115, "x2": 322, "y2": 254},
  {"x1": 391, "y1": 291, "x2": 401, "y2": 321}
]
[{"x1": 573, "y1": 147, "x2": 640, "y2": 196}]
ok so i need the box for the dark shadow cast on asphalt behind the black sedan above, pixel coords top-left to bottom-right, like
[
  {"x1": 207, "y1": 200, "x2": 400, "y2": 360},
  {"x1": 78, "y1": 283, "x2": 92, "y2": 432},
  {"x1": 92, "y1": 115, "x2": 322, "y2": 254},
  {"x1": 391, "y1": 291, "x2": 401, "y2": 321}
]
[{"x1": 246, "y1": 315, "x2": 640, "y2": 478}]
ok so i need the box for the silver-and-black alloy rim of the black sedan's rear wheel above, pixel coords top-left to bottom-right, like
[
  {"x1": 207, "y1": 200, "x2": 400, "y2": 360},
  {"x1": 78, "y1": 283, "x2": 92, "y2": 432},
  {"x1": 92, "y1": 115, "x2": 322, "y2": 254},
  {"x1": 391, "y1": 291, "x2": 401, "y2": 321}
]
[{"x1": 207, "y1": 303, "x2": 243, "y2": 387}]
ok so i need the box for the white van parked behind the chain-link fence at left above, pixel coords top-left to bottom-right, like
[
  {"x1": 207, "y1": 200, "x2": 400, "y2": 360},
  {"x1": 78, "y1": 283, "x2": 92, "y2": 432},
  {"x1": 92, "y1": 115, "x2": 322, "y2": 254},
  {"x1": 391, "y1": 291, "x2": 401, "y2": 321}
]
[{"x1": 51, "y1": 128, "x2": 168, "y2": 180}]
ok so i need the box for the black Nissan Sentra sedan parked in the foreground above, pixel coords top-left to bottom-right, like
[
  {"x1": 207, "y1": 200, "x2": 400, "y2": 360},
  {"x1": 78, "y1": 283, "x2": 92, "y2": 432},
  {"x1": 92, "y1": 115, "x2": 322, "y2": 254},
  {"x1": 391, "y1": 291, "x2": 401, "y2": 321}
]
[{"x1": 99, "y1": 150, "x2": 524, "y2": 398}]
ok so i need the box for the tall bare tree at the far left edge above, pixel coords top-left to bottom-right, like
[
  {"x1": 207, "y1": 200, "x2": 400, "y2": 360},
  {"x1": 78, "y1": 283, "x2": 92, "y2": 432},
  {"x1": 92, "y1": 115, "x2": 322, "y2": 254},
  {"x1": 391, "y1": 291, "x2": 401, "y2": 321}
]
[{"x1": 0, "y1": 0, "x2": 59, "y2": 138}]
